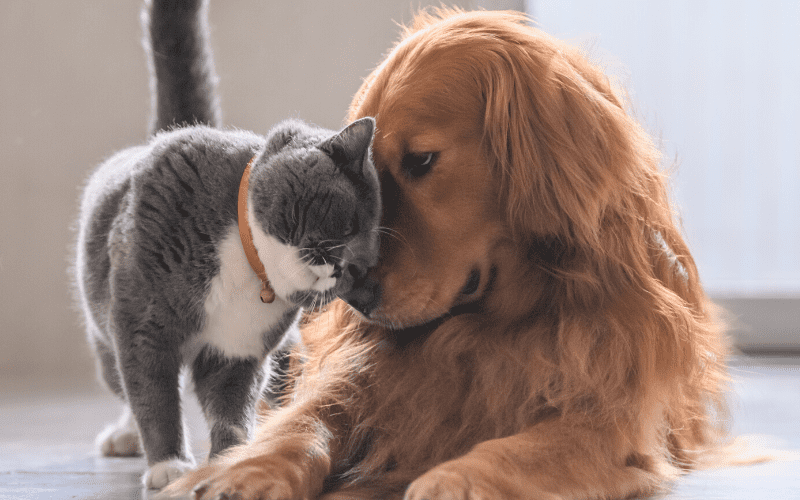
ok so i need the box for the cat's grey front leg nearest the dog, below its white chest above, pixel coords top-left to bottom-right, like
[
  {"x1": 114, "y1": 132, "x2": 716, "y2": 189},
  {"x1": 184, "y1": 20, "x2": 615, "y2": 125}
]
[{"x1": 192, "y1": 347, "x2": 264, "y2": 458}]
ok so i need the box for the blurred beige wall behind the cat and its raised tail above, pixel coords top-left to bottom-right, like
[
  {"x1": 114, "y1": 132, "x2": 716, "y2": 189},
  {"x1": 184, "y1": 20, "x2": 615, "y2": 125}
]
[{"x1": 0, "y1": 0, "x2": 476, "y2": 384}]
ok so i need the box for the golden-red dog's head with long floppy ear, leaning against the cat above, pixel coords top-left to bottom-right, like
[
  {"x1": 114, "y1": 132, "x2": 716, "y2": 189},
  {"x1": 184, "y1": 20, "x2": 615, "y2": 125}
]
[{"x1": 340, "y1": 11, "x2": 696, "y2": 328}]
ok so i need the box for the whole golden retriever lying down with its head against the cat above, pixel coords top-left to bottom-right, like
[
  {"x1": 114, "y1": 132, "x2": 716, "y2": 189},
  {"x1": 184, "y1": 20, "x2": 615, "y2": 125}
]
[{"x1": 171, "y1": 9, "x2": 727, "y2": 500}]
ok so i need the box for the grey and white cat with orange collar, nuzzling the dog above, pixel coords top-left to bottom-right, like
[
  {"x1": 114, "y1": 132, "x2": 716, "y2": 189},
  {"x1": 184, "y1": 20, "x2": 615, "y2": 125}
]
[{"x1": 74, "y1": 0, "x2": 380, "y2": 488}]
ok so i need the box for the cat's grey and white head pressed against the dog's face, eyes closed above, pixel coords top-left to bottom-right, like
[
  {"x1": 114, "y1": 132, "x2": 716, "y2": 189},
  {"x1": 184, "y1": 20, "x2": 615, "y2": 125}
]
[{"x1": 248, "y1": 118, "x2": 381, "y2": 307}]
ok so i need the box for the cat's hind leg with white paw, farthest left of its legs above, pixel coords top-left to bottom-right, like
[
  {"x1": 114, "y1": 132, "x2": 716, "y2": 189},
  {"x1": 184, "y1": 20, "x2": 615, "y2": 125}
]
[{"x1": 92, "y1": 335, "x2": 142, "y2": 457}]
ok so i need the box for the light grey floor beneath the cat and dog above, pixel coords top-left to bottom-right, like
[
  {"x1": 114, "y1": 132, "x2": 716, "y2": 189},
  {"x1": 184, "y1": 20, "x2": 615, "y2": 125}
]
[{"x1": 0, "y1": 358, "x2": 800, "y2": 500}]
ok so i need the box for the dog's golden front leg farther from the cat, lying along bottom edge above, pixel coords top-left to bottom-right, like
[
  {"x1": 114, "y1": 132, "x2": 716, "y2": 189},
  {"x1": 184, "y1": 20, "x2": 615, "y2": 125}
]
[{"x1": 405, "y1": 420, "x2": 663, "y2": 500}]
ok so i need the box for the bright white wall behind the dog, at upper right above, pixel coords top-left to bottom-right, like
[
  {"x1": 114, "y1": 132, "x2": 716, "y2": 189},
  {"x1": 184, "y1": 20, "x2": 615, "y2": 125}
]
[{"x1": 529, "y1": 0, "x2": 800, "y2": 296}]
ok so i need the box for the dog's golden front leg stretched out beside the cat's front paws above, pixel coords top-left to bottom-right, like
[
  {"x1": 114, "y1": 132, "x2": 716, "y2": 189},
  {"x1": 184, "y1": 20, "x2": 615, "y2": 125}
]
[{"x1": 165, "y1": 403, "x2": 335, "y2": 500}]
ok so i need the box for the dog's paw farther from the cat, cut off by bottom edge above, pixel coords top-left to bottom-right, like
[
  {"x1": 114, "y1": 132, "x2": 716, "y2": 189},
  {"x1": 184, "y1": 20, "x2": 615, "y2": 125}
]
[{"x1": 403, "y1": 467, "x2": 494, "y2": 500}]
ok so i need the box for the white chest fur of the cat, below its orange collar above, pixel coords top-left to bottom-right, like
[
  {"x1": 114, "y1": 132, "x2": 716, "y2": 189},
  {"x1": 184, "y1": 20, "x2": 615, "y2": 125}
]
[{"x1": 195, "y1": 227, "x2": 292, "y2": 359}]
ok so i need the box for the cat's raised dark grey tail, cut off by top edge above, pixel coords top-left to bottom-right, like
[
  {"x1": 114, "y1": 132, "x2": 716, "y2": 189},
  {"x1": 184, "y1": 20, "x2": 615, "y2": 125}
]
[{"x1": 142, "y1": 0, "x2": 222, "y2": 134}]
